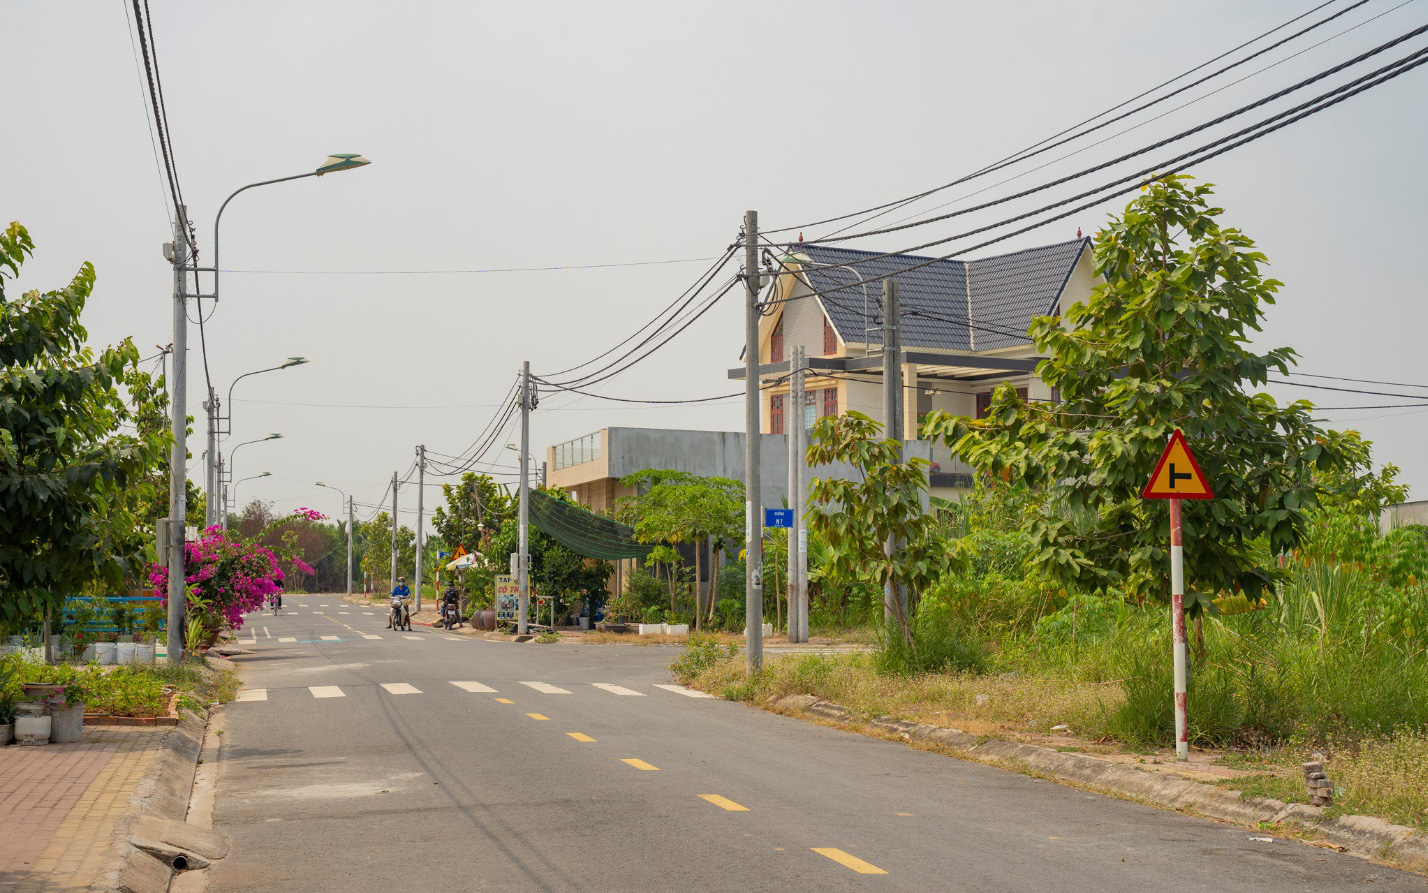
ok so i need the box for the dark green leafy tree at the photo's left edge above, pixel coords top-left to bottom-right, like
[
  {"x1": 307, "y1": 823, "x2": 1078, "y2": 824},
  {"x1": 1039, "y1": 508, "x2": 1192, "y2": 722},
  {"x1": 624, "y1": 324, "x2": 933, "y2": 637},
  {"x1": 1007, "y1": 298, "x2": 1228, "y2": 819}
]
[{"x1": 0, "y1": 223, "x2": 167, "y2": 626}]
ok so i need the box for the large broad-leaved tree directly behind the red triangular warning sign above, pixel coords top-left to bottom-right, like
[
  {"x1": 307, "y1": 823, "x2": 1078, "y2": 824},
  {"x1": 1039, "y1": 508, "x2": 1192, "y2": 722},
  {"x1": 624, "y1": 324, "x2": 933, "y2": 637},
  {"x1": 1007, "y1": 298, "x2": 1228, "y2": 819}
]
[{"x1": 925, "y1": 176, "x2": 1352, "y2": 604}]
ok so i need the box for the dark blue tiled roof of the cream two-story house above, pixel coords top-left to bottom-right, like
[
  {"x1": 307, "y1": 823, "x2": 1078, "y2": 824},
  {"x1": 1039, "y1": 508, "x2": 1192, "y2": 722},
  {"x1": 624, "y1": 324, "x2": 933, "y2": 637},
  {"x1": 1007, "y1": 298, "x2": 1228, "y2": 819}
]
[{"x1": 794, "y1": 239, "x2": 1091, "y2": 350}]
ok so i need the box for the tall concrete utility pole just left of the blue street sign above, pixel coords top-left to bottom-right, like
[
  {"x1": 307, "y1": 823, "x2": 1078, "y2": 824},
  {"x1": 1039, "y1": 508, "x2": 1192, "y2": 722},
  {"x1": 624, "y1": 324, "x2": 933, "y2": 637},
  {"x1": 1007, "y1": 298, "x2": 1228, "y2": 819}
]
[{"x1": 744, "y1": 211, "x2": 764, "y2": 673}]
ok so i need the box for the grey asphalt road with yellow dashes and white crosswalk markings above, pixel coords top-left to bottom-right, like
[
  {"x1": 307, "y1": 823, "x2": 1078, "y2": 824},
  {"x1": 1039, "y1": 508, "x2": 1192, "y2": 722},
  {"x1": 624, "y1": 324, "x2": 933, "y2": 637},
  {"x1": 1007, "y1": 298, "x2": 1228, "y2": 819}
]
[{"x1": 210, "y1": 596, "x2": 1428, "y2": 893}]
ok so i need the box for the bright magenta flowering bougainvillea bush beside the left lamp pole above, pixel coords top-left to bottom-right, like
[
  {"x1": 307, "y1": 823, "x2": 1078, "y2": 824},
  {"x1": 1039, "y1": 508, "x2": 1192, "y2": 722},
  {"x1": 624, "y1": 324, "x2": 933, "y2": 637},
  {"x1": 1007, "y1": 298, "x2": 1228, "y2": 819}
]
[{"x1": 149, "y1": 527, "x2": 313, "y2": 630}]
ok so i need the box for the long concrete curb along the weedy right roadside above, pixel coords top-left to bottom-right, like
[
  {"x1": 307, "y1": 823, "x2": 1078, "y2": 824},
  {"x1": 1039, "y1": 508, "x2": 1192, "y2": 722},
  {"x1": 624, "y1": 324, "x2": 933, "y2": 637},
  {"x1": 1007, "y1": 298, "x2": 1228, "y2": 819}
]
[{"x1": 774, "y1": 694, "x2": 1428, "y2": 873}]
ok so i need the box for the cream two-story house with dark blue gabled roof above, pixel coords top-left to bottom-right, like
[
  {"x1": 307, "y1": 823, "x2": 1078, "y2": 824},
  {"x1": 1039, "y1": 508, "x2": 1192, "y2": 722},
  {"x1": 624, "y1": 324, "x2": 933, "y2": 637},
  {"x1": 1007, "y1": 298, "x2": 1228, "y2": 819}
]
[{"x1": 730, "y1": 239, "x2": 1098, "y2": 496}]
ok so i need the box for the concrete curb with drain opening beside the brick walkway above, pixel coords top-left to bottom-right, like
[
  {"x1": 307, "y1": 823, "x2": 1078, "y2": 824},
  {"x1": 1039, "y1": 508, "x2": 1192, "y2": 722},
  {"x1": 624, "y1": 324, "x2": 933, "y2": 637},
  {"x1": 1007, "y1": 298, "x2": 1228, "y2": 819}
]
[{"x1": 105, "y1": 710, "x2": 208, "y2": 893}]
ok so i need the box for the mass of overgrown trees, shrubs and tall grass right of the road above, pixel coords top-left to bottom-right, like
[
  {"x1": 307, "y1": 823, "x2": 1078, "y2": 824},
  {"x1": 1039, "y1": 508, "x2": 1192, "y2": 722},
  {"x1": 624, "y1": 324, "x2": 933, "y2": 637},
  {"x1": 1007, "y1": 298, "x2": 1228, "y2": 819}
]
[{"x1": 674, "y1": 180, "x2": 1428, "y2": 827}]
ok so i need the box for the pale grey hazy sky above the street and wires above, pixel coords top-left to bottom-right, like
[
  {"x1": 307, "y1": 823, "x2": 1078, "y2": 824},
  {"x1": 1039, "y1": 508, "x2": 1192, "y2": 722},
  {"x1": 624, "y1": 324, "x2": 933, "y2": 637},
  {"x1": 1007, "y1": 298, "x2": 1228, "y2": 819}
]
[{"x1": 0, "y1": 0, "x2": 1428, "y2": 522}]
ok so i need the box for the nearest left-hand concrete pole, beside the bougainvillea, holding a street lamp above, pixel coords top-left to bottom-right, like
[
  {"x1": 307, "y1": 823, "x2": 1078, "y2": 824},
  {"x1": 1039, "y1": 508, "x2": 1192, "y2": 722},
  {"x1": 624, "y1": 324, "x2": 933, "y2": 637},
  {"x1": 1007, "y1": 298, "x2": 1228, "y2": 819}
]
[{"x1": 164, "y1": 206, "x2": 188, "y2": 663}]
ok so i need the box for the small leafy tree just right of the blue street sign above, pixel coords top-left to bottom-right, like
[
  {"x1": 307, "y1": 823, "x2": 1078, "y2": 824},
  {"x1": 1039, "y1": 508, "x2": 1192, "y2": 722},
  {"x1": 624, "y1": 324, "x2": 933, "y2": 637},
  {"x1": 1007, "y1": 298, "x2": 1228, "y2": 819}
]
[{"x1": 807, "y1": 411, "x2": 962, "y2": 644}]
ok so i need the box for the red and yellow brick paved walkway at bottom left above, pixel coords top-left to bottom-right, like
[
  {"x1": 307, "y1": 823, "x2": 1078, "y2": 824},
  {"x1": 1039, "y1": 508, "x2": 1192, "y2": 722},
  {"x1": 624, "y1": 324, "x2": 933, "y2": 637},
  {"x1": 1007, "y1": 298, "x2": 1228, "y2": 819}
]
[{"x1": 0, "y1": 727, "x2": 167, "y2": 893}]
